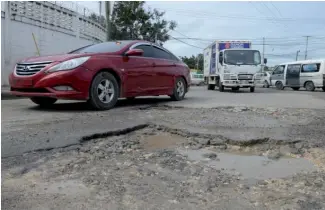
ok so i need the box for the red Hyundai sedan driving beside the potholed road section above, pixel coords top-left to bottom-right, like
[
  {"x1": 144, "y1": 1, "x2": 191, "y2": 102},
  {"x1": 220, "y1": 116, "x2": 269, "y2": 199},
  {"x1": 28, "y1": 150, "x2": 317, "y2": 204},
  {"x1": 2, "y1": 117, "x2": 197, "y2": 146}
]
[{"x1": 9, "y1": 41, "x2": 190, "y2": 109}]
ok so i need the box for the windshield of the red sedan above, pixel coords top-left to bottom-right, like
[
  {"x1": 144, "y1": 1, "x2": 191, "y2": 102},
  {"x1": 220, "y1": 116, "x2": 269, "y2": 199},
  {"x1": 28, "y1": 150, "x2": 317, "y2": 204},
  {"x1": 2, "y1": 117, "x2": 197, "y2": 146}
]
[{"x1": 69, "y1": 41, "x2": 131, "y2": 54}]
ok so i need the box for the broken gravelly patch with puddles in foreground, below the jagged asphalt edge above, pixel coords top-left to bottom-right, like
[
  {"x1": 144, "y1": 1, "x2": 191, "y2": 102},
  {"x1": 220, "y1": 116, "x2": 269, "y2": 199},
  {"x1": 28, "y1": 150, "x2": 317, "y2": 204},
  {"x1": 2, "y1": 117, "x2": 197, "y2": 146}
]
[{"x1": 2, "y1": 126, "x2": 325, "y2": 210}]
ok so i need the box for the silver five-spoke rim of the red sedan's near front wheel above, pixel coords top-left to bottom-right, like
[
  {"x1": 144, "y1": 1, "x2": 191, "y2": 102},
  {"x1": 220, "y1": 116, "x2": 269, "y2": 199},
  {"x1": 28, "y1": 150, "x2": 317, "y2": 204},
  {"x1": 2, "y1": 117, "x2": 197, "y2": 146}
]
[{"x1": 97, "y1": 79, "x2": 115, "y2": 104}]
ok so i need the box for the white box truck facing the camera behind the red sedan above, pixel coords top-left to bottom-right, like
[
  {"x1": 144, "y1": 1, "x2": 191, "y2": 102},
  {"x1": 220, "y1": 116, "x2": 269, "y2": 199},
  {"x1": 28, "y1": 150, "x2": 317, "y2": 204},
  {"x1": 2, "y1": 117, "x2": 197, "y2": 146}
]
[{"x1": 203, "y1": 41, "x2": 267, "y2": 92}]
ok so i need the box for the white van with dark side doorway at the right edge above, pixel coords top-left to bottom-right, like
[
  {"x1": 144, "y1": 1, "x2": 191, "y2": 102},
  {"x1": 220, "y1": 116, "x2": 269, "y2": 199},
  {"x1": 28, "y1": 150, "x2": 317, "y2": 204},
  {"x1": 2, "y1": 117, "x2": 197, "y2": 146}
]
[{"x1": 270, "y1": 59, "x2": 325, "y2": 91}]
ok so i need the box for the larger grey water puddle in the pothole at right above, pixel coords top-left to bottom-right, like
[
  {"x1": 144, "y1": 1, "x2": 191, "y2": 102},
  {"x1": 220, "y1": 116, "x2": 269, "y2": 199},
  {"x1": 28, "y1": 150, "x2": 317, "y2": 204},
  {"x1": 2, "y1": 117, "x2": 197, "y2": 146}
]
[{"x1": 179, "y1": 149, "x2": 316, "y2": 180}]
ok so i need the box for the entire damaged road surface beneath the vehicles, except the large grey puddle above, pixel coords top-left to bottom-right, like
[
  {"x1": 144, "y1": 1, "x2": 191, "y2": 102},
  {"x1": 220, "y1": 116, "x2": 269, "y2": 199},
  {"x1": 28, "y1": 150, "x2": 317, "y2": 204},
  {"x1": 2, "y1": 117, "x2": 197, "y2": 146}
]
[{"x1": 1, "y1": 87, "x2": 325, "y2": 209}]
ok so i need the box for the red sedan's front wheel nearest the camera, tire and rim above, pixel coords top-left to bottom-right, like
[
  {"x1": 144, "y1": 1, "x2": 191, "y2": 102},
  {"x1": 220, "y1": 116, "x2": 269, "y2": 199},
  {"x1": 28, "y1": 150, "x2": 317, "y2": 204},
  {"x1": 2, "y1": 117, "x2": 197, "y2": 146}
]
[{"x1": 88, "y1": 72, "x2": 120, "y2": 110}]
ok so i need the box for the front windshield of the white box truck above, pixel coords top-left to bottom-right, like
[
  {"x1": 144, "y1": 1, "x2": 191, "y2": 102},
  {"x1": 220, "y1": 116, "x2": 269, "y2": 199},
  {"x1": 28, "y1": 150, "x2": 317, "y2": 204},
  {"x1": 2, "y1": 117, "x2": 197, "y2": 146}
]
[{"x1": 225, "y1": 50, "x2": 261, "y2": 65}]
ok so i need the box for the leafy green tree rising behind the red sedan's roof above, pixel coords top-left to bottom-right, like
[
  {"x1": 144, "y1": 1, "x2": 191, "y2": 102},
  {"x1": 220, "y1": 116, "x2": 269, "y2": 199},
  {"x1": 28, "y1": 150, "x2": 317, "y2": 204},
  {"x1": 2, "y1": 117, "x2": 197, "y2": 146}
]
[{"x1": 110, "y1": 1, "x2": 176, "y2": 43}]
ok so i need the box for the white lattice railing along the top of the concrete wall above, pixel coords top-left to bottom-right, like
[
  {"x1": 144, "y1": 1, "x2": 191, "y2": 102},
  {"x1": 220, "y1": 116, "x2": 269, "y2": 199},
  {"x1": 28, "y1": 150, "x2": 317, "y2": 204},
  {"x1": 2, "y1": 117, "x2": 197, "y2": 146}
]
[{"x1": 9, "y1": 1, "x2": 106, "y2": 41}]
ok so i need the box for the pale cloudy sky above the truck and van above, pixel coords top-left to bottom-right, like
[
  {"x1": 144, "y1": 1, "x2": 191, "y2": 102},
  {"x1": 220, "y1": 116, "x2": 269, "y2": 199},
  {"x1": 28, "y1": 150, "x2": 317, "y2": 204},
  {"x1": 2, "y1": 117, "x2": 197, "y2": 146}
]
[{"x1": 78, "y1": 1, "x2": 325, "y2": 65}]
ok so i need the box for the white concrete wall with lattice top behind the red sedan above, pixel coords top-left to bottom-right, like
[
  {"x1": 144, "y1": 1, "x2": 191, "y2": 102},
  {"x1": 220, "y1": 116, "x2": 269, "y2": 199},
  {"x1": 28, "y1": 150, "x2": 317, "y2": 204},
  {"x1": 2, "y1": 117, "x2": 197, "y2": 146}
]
[{"x1": 1, "y1": 2, "x2": 106, "y2": 85}]
